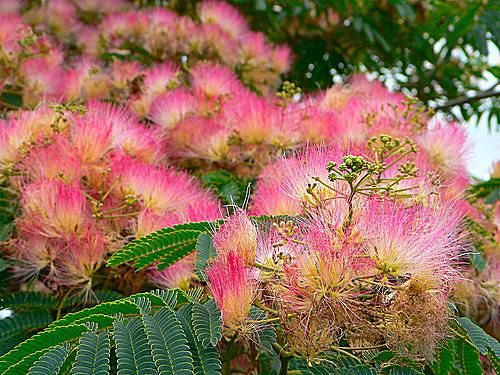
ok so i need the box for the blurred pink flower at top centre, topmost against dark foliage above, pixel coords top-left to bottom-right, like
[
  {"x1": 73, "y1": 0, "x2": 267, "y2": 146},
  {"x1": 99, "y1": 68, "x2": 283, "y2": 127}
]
[{"x1": 199, "y1": 0, "x2": 249, "y2": 39}]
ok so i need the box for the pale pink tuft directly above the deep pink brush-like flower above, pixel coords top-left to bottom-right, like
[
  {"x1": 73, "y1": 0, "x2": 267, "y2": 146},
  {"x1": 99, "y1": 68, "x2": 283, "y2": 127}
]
[{"x1": 213, "y1": 210, "x2": 257, "y2": 265}]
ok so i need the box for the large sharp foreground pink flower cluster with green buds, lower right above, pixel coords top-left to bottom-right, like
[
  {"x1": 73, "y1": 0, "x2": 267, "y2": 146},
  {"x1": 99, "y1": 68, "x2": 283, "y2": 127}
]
[{"x1": 207, "y1": 148, "x2": 466, "y2": 359}]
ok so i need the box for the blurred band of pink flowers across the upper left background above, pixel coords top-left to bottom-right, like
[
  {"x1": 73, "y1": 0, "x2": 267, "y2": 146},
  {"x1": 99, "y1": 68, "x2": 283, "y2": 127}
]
[{"x1": 0, "y1": 0, "x2": 291, "y2": 110}]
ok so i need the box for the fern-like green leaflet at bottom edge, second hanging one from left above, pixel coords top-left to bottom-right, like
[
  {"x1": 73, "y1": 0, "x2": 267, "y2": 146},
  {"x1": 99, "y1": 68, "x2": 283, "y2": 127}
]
[{"x1": 71, "y1": 331, "x2": 110, "y2": 375}]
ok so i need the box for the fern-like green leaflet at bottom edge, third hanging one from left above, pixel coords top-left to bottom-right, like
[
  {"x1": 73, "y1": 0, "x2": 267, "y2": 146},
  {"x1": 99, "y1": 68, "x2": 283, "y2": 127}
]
[{"x1": 114, "y1": 317, "x2": 157, "y2": 375}]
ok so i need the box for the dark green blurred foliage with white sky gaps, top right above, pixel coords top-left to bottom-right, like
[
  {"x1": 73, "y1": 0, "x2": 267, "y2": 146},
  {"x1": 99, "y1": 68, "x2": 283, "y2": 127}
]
[{"x1": 228, "y1": 0, "x2": 500, "y2": 129}]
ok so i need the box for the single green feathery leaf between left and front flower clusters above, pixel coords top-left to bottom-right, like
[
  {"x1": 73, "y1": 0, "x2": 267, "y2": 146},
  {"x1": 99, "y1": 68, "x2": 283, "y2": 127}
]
[{"x1": 108, "y1": 221, "x2": 217, "y2": 269}]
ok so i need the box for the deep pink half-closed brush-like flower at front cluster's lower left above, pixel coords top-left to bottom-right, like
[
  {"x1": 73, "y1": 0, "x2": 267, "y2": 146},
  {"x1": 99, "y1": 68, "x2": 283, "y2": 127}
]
[{"x1": 207, "y1": 252, "x2": 258, "y2": 329}]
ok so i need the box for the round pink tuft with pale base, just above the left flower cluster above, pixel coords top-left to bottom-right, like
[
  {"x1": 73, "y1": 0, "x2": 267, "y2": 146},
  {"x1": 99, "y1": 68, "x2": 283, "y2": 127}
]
[{"x1": 149, "y1": 88, "x2": 196, "y2": 130}]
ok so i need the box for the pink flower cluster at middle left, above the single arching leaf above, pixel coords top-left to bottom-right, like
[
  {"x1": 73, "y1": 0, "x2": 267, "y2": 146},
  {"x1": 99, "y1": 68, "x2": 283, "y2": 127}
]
[{"x1": 0, "y1": 102, "x2": 220, "y2": 289}]
